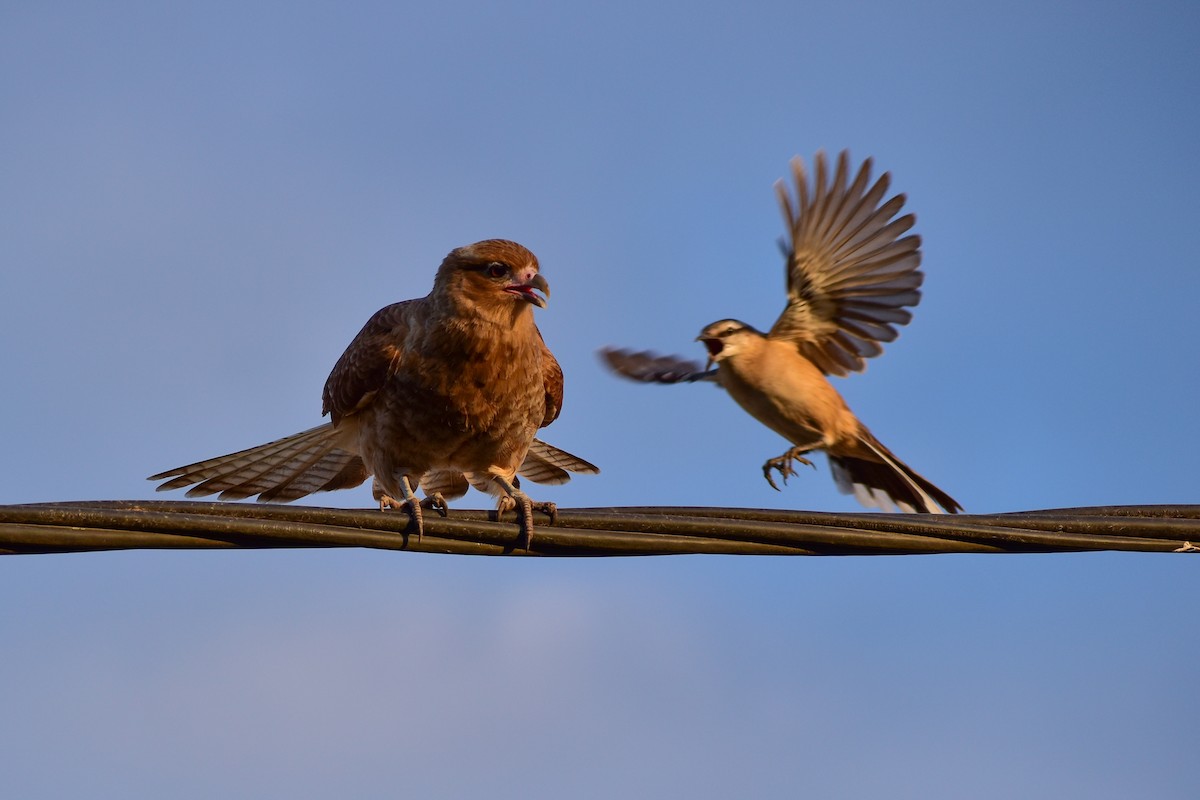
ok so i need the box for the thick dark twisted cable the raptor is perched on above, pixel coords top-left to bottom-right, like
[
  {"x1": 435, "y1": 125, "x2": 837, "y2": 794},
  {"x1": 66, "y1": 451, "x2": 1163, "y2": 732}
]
[{"x1": 0, "y1": 500, "x2": 1200, "y2": 557}]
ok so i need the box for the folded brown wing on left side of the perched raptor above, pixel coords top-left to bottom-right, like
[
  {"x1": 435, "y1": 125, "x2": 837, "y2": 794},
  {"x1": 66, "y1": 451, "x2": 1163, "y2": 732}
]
[{"x1": 320, "y1": 297, "x2": 424, "y2": 426}]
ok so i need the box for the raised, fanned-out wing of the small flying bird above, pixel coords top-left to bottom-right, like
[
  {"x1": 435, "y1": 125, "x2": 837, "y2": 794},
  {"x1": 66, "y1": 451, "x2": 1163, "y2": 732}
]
[{"x1": 768, "y1": 150, "x2": 924, "y2": 375}]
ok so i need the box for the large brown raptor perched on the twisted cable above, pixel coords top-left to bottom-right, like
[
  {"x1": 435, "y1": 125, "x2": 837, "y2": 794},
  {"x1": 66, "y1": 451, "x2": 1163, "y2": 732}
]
[{"x1": 150, "y1": 239, "x2": 599, "y2": 537}]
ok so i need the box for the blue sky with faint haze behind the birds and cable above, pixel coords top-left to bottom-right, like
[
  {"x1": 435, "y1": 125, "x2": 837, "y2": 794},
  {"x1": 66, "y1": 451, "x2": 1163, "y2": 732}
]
[{"x1": 0, "y1": 0, "x2": 1200, "y2": 799}]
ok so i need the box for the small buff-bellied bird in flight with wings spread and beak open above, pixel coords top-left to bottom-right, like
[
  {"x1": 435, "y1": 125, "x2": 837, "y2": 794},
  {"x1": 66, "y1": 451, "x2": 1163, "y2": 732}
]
[{"x1": 601, "y1": 151, "x2": 962, "y2": 513}]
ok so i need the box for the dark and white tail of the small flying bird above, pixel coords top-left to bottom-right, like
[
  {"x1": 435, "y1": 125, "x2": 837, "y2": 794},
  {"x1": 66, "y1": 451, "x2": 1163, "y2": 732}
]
[{"x1": 829, "y1": 432, "x2": 962, "y2": 513}]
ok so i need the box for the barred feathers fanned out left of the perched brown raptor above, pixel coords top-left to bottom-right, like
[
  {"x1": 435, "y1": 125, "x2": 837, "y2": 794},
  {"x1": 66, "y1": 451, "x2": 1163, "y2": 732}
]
[{"x1": 149, "y1": 422, "x2": 370, "y2": 503}]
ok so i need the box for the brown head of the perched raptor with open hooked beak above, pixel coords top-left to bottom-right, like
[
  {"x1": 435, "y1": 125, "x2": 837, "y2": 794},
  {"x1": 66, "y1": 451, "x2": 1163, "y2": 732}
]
[{"x1": 433, "y1": 239, "x2": 550, "y2": 314}]
